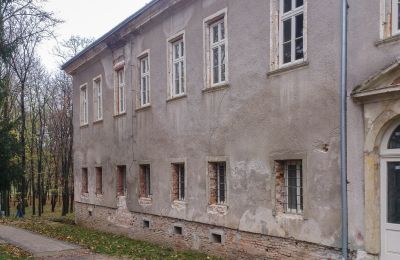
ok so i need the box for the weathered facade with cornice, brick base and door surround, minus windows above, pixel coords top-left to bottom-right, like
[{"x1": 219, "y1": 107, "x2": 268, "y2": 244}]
[{"x1": 64, "y1": 0, "x2": 400, "y2": 259}]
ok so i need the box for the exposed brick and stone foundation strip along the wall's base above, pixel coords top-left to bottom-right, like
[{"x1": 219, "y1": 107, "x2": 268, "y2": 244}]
[{"x1": 75, "y1": 199, "x2": 340, "y2": 260}]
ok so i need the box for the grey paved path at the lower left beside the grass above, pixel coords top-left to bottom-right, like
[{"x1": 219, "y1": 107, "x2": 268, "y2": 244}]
[{"x1": 0, "y1": 225, "x2": 116, "y2": 260}]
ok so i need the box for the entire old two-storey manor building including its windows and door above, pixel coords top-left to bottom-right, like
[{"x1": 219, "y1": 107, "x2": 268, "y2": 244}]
[{"x1": 63, "y1": 0, "x2": 400, "y2": 260}]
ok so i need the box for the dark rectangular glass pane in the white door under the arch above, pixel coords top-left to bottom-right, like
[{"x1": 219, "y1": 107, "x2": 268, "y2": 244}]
[{"x1": 387, "y1": 162, "x2": 400, "y2": 224}]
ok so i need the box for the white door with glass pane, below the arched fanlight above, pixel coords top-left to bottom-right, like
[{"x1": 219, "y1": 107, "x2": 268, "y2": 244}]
[{"x1": 381, "y1": 156, "x2": 400, "y2": 260}]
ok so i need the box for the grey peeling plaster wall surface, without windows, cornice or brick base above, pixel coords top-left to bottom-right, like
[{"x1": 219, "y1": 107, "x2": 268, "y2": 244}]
[{"x1": 73, "y1": 0, "x2": 400, "y2": 254}]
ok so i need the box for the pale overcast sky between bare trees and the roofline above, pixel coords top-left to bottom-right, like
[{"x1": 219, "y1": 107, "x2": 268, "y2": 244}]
[{"x1": 39, "y1": 0, "x2": 150, "y2": 70}]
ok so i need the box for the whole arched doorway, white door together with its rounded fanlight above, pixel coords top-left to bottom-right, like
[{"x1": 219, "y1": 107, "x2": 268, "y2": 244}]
[{"x1": 380, "y1": 122, "x2": 400, "y2": 260}]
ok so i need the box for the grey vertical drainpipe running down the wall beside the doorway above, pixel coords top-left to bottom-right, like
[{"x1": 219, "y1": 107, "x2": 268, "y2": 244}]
[{"x1": 340, "y1": 0, "x2": 348, "y2": 260}]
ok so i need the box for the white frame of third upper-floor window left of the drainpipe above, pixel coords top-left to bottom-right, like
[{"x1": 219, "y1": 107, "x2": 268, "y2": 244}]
[{"x1": 167, "y1": 31, "x2": 186, "y2": 98}]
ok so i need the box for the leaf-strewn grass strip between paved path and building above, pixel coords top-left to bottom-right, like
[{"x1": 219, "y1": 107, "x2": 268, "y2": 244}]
[{"x1": 0, "y1": 204, "x2": 217, "y2": 260}]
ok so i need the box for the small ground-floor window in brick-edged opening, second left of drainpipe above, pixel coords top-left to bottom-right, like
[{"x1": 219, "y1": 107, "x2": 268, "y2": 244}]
[{"x1": 209, "y1": 162, "x2": 226, "y2": 204}]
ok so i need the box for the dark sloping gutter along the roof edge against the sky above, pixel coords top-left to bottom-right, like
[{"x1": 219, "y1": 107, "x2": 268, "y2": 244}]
[{"x1": 61, "y1": 0, "x2": 161, "y2": 70}]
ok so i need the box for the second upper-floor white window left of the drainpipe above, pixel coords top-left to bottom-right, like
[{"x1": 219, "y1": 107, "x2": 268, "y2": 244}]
[{"x1": 205, "y1": 9, "x2": 228, "y2": 87}]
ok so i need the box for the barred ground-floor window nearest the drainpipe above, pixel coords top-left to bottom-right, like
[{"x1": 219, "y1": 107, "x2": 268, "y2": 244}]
[{"x1": 284, "y1": 160, "x2": 303, "y2": 213}]
